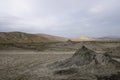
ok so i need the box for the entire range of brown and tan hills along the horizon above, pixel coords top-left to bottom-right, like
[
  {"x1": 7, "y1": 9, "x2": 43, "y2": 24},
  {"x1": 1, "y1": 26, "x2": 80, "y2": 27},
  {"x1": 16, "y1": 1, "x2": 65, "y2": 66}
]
[{"x1": 0, "y1": 32, "x2": 120, "y2": 43}]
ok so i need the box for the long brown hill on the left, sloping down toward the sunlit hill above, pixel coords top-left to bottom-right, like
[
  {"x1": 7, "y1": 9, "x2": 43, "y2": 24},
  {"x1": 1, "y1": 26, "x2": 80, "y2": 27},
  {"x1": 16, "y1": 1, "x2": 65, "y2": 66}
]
[{"x1": 0, "y1": 32, "x2": 67, "y2": 43}]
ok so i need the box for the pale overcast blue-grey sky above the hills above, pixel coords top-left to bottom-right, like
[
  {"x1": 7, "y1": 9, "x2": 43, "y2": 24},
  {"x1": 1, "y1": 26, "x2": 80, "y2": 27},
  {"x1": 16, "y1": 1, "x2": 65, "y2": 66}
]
[{"x1": 0, "y1": 0, "x2": 120, "y2": 37}]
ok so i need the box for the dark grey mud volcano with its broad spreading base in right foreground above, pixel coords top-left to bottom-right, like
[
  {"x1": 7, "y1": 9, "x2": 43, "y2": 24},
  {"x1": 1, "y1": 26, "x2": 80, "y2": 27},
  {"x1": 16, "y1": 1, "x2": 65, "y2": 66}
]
[{"x1": 48, "y1": 46, "x2": 120, "y2": 80}]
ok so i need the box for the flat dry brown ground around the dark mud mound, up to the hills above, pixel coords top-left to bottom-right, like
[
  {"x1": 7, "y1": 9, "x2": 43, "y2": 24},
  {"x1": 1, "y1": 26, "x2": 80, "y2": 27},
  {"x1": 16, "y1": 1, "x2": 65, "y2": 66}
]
[{"x1": 0, "y1": 42, "x2": 120, "y2": 80}]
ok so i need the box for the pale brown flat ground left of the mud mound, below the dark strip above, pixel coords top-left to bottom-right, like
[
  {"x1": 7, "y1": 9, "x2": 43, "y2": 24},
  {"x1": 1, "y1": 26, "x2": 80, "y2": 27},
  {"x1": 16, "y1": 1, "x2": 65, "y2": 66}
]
[{"x1": 0, "y1": 51, "x2": 119, "y2": 80}]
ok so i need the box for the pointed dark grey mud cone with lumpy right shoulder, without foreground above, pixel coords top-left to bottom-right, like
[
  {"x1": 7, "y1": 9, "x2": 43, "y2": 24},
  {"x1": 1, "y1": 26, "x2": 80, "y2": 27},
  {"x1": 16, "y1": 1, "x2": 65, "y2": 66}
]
[{"x1": 49, "y1": 46, "x2": 119, "y2": 68}]
